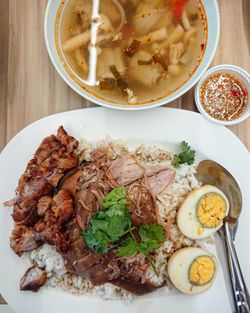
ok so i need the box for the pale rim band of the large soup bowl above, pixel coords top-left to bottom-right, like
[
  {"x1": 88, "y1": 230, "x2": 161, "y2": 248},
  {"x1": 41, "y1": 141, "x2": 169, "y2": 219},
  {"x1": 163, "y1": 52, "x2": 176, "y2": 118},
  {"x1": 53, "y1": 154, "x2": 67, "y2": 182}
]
[{"x1": 44, "y1": 0, "x2": 220, "y2": 111}]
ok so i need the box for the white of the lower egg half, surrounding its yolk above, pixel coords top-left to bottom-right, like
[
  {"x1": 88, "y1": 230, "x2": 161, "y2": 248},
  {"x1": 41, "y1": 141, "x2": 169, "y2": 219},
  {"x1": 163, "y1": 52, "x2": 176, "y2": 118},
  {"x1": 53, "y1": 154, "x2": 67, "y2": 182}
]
[{"x1": 167, "y1": 247, "x2": 217, "y2": 295}]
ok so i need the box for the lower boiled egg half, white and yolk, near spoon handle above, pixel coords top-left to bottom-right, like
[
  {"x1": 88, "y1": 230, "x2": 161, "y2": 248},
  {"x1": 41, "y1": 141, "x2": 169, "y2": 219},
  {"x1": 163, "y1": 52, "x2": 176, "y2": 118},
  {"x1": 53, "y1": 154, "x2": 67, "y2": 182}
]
[{"x1": 167, "y1": 247, "x2": 217, "y2": 295}]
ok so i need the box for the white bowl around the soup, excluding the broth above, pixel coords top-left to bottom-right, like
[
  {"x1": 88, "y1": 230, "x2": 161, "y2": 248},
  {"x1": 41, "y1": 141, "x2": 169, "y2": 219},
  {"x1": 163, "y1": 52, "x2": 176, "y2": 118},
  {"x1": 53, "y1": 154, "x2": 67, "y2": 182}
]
[{"x1": 44, "y1": 0, "x2": 220, "y2": 110}]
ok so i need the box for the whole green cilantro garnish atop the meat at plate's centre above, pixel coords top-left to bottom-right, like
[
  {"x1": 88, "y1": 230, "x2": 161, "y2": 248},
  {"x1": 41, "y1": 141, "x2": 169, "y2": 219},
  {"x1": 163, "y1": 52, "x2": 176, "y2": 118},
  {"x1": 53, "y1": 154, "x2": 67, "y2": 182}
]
[{"x1": 80, "y1": 187, "x2": 166, "y2": 275}]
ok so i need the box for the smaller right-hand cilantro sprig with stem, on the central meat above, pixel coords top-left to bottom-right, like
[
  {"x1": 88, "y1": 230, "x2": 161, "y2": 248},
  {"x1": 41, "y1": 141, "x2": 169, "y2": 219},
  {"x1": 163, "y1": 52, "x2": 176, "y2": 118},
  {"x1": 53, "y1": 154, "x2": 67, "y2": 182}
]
[{"x1": 117, "y1": 224, "x2": 166, "y2": 276}]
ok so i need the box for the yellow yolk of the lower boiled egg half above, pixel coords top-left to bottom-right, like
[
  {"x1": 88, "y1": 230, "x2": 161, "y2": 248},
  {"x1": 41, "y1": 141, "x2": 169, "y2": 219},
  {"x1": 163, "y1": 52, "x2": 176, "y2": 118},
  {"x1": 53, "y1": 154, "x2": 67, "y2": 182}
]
[{"x1": 189, "y1": 255, "x2": 215, "y2": 286}]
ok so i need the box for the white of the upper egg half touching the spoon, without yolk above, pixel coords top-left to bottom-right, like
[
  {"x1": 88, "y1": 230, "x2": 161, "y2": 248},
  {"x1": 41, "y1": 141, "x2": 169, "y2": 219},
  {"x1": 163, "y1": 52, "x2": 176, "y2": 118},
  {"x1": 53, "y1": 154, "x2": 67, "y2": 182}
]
[{"x1": 177, "y1": 185, "x2": 229, "y2": 239}]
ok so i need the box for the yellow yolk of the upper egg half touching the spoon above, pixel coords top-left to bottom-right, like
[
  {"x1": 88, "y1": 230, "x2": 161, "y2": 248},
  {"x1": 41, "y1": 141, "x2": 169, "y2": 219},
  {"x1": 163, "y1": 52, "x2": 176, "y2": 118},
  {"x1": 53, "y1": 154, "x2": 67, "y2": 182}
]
[{"x1": 196, "y1": 192, "x2": 227, "y2": 228}]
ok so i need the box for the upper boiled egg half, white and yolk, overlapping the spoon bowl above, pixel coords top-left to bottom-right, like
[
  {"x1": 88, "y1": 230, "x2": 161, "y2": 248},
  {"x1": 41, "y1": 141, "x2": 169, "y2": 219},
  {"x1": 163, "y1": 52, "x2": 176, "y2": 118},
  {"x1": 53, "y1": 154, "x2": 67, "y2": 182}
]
[{"x1": 177, "y1": 185, "x2": 229, "y2": 239}]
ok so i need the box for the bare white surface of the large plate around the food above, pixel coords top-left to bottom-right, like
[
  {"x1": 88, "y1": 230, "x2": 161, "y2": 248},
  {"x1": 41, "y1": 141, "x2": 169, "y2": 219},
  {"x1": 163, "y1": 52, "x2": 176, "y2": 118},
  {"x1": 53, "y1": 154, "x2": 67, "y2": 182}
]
[{"x1": 0, "y1": 108, "x2": 250, "y2": 313}]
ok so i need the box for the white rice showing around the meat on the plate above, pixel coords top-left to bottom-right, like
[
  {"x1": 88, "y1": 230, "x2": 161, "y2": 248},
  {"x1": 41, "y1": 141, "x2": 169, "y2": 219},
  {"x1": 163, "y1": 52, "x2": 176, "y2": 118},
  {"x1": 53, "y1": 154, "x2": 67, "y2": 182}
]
[{"x1": 30, "y1": 138, "x2": 205, "y2": 302}]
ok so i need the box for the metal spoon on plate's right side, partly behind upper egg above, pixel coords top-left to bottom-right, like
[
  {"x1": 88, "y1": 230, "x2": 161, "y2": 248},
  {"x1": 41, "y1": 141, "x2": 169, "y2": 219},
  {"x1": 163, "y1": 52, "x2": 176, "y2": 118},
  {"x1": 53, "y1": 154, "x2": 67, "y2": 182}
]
[{"x1": 196, "y1": 160, "x2": 250, "y2": 313}]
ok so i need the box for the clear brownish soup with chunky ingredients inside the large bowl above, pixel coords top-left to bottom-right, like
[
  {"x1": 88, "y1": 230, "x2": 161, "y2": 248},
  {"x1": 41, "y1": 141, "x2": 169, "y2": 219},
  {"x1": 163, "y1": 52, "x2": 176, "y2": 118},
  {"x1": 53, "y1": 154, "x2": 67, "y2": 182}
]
[{"x1": 56, "y1": 0, "x2": 207, "y2": 105}]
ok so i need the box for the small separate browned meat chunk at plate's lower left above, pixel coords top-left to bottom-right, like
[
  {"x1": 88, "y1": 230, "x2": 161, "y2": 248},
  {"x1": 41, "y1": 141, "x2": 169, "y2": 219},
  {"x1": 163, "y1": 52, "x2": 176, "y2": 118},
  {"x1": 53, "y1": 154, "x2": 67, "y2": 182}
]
[{"x1": 20, "y1": 265, "x2": 47, "y2": 292}]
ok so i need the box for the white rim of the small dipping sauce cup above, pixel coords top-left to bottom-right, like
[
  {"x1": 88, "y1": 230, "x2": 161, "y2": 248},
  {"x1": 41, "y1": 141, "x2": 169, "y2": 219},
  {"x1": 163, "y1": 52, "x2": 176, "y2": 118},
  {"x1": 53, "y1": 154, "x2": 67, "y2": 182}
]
[{"x1": 194, "y1": 64, "x2": 250, "y2": 126}]
